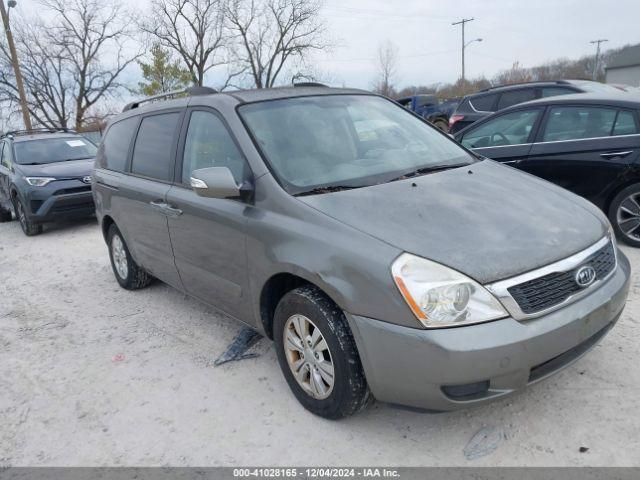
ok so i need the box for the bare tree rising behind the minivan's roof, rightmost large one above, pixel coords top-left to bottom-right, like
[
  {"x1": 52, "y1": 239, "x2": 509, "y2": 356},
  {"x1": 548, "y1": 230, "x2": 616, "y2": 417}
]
[{"x1": 227, "y1": 0, "x2": 328, "y2": 88}]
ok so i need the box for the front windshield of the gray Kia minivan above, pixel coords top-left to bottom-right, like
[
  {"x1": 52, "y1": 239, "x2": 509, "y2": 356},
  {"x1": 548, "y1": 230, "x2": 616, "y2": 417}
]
[{"x1": 238, "y1": 95, "x2": 476, "y2": 195}]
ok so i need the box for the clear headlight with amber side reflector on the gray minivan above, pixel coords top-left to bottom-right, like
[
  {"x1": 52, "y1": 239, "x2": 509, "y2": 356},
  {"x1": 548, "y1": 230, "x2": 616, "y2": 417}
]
[{"x1": 391, "y1": 253, "x2": 507, "y2": 328}]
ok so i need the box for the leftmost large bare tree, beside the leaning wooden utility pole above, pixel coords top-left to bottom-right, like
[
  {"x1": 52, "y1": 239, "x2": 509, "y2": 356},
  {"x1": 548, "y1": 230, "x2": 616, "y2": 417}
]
[{"x1": 0, "y1": 0, "x2": 139, "y2": 129}]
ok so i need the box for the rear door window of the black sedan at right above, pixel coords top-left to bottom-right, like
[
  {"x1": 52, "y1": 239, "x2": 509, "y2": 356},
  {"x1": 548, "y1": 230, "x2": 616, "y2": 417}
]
[{"x1": 542, "y1": 107, "x2": 616, "y2": 142}]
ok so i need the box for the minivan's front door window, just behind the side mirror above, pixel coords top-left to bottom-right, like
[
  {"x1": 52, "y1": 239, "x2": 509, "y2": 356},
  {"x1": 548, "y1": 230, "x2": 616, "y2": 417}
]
[{"x1": 182, "y1": 110, "x2": 248, "y2": 185}]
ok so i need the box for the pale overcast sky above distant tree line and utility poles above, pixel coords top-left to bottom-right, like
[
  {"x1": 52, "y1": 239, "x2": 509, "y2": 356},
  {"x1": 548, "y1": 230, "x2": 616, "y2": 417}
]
[{"x1": 12, "y1": 0, "x2": 640, "y2": 88}]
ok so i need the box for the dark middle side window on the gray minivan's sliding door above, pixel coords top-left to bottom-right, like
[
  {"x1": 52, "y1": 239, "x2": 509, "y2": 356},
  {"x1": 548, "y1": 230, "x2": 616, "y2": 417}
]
[{"x1": 131, "y1": 112, "x2": 180, "y2": 181}]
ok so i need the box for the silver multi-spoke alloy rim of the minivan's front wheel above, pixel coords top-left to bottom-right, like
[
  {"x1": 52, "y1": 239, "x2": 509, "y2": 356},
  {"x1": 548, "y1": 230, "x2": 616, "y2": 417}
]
[{"x1": 282, "y1": 314, "x2": 335, "y2": 400}]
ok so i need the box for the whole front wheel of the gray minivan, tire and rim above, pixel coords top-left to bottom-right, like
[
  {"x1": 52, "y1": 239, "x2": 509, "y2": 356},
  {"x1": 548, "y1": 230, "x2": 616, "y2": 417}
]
[{"x1": 273, "y1": 286, "x2": 370, "y2": 419}]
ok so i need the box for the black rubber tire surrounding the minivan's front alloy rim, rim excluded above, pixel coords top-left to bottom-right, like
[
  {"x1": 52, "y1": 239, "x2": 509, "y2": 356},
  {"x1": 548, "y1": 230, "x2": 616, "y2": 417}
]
[{"x1": 273, "y1": 285, "x2": 372, "y2": 419}]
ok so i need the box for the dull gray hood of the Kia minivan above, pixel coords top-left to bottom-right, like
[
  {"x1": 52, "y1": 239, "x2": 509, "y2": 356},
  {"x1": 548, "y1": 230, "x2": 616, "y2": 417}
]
[{"x1": 298, "y1": 160, "x2": 607, "y2": 283}]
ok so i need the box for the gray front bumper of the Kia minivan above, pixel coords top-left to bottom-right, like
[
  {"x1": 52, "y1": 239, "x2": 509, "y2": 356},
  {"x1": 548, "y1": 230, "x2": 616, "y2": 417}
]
[{"x1": 347, "y1": 251, "x2": 630, "y2": 411}]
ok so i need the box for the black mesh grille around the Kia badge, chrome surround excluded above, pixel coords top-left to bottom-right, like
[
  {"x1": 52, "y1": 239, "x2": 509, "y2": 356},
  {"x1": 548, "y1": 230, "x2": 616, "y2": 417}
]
[{"x1": 508, "y1": 242, "x2": 616, "y2": 314}]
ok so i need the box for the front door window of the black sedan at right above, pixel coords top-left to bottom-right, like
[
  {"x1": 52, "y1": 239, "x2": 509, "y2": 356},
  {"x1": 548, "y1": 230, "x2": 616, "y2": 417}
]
[{"x1": 461, "y1": 110, "x2": 540, "y2": 148}]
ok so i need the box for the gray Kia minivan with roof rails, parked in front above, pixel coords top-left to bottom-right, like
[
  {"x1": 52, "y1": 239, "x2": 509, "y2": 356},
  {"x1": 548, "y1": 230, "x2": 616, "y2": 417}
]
[{"x1": 92, "y1": 85, "x2": 630, "y2": 418}]
